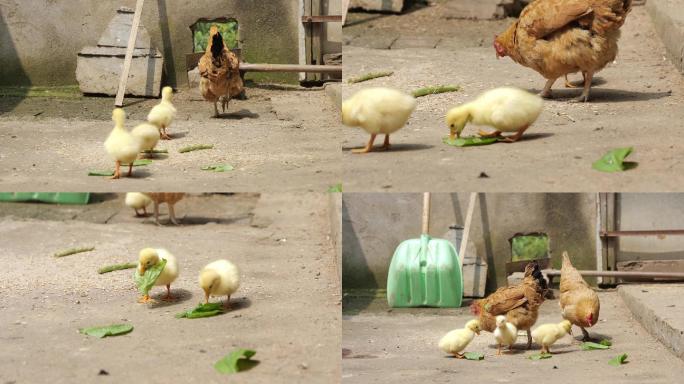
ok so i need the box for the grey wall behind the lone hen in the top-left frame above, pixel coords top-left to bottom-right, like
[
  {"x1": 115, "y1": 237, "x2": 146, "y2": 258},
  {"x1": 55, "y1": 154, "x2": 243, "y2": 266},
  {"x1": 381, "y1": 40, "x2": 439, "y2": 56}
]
[{"x1": 0, "y1": 0, "x2": 300, "y2": 86}]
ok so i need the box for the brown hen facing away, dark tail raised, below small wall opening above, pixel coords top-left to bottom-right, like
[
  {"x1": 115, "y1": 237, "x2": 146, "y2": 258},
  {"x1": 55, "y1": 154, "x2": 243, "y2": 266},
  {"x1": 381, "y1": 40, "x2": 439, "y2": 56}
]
[{"x1": 199, "y1": 25, "x2": 244, "y2": 117}]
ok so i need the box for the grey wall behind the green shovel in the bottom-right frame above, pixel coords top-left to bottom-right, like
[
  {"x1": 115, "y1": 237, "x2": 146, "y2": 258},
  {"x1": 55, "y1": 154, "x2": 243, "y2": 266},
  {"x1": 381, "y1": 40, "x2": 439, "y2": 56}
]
[{"x1": 342, "y1": 193, "x2": 596, "y2": 292}]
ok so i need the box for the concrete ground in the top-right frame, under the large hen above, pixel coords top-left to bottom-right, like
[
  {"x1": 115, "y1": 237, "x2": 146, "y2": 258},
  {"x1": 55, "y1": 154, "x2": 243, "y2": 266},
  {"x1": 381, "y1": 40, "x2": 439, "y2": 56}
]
[{"x1": 342, "y1": 0, "x2": 684, "y2": 192}]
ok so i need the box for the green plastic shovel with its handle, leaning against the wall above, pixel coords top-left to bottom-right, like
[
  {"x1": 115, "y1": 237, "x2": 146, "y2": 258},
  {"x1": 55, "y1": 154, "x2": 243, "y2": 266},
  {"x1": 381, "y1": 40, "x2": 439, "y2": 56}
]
[{"x1": 387, "y1": 193, "x2": 463, "y2": 308}]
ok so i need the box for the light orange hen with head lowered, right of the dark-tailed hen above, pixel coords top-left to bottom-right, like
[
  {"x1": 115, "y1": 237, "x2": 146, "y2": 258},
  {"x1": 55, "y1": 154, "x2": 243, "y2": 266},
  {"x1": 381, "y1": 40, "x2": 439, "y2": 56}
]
[{"x1": 558, "y1": 252, "x2": 601, "y2": 341}]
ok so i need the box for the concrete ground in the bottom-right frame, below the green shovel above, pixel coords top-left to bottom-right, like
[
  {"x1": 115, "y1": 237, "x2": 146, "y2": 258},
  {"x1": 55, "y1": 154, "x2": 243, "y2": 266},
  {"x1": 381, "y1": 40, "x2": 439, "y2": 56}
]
[{"x1": 342, "y1": 291, "x2": 684, "y2": 384}]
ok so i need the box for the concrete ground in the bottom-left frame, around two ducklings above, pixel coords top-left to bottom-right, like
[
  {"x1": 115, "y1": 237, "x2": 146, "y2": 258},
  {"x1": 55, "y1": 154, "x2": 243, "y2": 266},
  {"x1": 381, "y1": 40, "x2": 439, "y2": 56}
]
[{"x1": 0, "y1": 194, "x2": 340, "y2": 383}]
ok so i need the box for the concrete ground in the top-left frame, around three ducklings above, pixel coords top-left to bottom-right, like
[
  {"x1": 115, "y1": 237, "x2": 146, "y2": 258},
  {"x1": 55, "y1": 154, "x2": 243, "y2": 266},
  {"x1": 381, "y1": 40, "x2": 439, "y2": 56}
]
[{"x1": 0, "y1": 85, "x2": 340, "y2": 192}]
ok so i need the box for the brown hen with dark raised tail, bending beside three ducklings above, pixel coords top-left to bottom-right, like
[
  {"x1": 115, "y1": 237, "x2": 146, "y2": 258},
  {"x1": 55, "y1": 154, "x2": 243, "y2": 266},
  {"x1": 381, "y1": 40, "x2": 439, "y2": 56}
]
[{"x1": 470, "y1": 263, "x2": 547, "y2": 349}]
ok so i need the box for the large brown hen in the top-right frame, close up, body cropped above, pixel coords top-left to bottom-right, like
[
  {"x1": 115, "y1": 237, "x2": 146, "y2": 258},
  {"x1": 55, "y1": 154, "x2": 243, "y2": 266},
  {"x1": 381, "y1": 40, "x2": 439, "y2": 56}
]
[{"x1": 494, "y1": 0, "x2": 632, "y2": 101}]
